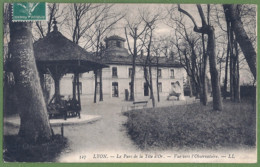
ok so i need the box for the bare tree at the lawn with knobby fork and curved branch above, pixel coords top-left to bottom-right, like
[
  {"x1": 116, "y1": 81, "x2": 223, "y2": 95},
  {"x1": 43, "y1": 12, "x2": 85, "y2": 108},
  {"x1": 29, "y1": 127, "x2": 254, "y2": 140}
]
[{"x1": 178, "y1": 5, "x2": 223, "y2": 110}]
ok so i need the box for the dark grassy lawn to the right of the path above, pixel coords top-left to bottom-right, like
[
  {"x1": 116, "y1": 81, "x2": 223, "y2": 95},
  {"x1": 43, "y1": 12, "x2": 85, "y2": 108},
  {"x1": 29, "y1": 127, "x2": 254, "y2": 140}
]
[{"x1": 125, "y1": 101, "x2": 256, "y2": 149}]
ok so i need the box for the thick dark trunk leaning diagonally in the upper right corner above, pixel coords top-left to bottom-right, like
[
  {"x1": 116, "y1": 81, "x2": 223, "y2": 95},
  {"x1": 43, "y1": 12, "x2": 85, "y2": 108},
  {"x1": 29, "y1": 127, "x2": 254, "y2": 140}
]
[{"x1": 223, "y1": 5, "x2": 256, "y2": 79}]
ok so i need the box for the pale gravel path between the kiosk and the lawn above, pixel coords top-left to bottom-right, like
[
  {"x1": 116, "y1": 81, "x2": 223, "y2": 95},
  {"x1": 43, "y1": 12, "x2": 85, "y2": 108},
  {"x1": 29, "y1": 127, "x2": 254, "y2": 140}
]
[{"x1": 54, "y1": 99, "x2": 138, "y2": 162}]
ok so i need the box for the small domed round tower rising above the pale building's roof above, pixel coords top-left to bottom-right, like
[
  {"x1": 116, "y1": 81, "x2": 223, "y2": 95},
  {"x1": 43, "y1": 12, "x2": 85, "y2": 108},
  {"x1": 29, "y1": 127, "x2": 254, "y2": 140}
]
[{"x1": 104, "y1": 35, "x2": 129, "y2": 56}]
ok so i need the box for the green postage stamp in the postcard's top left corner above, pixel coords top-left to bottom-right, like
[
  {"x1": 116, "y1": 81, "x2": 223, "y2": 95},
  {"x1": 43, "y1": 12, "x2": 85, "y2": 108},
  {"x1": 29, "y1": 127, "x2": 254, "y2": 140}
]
[{"x1": 12, "y1": 2, "x2": 47, "y2": 22}]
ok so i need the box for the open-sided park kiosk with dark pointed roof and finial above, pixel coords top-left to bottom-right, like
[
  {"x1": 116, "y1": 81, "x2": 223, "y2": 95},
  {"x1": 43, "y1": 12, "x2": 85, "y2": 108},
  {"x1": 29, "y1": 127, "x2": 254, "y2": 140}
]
[{"x1": 34, "y1": 20, "x2": 108, "y2": 119}]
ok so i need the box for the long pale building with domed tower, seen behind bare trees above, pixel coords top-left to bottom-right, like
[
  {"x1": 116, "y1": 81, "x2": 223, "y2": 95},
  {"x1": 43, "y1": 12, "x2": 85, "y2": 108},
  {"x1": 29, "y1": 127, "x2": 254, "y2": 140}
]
[{"x1": 51, "y1": 35, "x2": 187, "y2": 100}]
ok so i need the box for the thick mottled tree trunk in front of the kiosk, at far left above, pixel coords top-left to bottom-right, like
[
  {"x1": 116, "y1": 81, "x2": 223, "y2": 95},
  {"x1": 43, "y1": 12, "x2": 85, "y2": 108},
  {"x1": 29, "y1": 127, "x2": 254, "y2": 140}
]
[{"x1": 10, "y1": 22, "x2": 51, "y2": 142}]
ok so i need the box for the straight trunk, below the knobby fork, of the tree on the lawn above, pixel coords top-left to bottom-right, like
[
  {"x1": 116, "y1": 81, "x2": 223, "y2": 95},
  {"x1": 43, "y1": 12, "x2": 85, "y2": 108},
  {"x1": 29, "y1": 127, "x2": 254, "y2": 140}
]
[{"x1": 207, "y1": 27, "x2": 223, "y2": 111}]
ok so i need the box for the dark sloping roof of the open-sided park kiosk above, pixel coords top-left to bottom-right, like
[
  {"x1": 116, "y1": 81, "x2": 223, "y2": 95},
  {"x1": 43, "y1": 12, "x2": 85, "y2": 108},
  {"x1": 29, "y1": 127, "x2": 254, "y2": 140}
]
[{"x1": 34, "y1": 31, "x2": 106, "y2": 73}]
